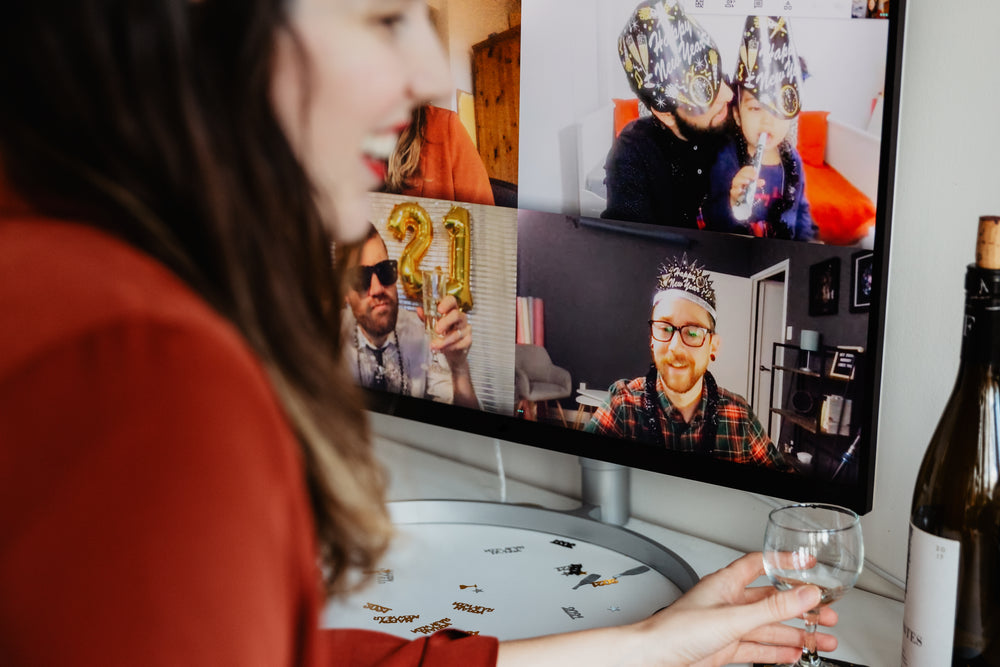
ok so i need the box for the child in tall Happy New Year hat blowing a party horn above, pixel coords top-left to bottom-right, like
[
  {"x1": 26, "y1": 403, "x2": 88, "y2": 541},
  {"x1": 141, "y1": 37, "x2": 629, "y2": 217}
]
[{"x1": 702, "y1": 16, "x2": 816, "y2": 241}]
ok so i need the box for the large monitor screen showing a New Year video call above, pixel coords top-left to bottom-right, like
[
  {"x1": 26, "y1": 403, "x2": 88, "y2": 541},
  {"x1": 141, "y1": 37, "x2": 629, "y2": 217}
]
[{"x1": 336, "y1": 0, "x2": 902, "y2": 512}]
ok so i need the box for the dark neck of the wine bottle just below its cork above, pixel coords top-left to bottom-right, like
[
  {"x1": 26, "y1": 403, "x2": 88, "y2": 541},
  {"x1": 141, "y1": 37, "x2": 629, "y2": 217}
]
[{"x1": 962, "y1": 265, "x2": 1000, "y2": 372}]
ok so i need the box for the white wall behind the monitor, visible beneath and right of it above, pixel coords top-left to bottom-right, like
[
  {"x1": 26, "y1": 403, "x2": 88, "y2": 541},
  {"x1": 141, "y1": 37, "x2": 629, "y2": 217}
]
[{"x1": 377, "y1": 0, "x2": 1000, "y2": 596}]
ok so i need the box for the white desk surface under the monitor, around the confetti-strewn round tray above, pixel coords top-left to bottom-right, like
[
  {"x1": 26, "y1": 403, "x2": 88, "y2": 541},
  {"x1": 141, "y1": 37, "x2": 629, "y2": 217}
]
[{"x1": 376, "y1": 439, "x2": 903, "y2": 667}]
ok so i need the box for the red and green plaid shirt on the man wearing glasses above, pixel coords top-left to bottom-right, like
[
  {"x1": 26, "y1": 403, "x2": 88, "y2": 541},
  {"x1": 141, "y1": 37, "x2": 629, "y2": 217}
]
[{"x1": 586, "y1": 377, "x2": 787, "y2": 470}]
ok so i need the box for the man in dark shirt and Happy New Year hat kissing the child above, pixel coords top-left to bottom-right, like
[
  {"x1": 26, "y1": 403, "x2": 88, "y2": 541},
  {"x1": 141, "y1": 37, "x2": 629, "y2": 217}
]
[{"x1": 601, "y1": 0, "x2": 733, "y2": 228}]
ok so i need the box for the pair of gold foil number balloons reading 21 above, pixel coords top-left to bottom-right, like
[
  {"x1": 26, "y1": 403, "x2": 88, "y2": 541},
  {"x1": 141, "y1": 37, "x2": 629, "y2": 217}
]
[{"x1": 386, "y1": 202, "x2": 472, "y2": 312}]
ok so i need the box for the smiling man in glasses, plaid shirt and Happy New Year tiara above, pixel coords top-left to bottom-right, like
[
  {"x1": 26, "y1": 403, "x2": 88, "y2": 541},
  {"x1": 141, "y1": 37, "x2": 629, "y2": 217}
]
[{"x1": 587, "y1": 257, "x2": 786, "y2": 469}]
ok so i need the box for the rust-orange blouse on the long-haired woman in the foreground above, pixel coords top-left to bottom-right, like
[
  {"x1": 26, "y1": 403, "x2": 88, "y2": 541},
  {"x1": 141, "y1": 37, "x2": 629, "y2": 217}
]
[{"x1": 0, "y1": 215, "x2": 497, "y2": 667}]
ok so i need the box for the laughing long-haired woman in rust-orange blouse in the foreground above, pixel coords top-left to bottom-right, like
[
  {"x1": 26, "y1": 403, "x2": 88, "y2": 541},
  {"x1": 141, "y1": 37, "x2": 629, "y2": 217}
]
[{"x1": 0, "y1": 0, "x2": 833, "y2": 667}]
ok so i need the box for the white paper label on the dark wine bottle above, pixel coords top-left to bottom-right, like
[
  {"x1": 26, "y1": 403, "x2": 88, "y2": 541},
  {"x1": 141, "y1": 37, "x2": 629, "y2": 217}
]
[{"x1": 902, "y1": 522, "x2": 962, "y2": 667}]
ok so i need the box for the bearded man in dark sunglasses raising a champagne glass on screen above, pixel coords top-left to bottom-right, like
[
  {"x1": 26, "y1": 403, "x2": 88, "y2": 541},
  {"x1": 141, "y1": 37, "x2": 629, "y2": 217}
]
[{"x1": 336, "y1": 226, "x2": 479, "y2": 408}]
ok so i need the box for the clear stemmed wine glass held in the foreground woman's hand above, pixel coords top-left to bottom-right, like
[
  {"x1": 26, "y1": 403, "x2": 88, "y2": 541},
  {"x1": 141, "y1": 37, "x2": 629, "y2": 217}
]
[{"x1": 764, "y1": 504, "x2": 865, "y2": 667}]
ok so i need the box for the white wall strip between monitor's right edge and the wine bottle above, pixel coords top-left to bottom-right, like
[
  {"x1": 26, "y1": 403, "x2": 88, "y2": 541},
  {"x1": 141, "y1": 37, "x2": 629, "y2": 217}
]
[{"x1": 865, "y1": 0, "x2": 1000, "y2": 576}]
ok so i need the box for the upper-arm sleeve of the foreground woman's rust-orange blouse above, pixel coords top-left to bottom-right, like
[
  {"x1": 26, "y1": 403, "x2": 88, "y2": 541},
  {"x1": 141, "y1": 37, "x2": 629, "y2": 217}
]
[{"x1": 0, "y1": 319, "x2": 320, "y2": 667}]
